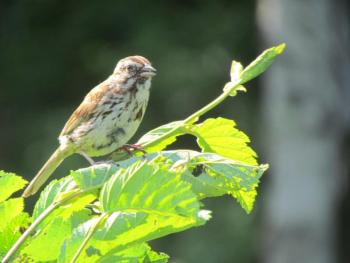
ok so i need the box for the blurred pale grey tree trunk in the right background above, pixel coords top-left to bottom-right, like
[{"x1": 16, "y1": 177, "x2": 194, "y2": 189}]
[{"x1": 257, "y1": 0, "x2": 350, "y2": 263}]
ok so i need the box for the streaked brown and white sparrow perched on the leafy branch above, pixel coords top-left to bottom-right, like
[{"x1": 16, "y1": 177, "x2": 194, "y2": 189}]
[{"x1": 23, "y1": 56, "x2": 156, "y2": 197}]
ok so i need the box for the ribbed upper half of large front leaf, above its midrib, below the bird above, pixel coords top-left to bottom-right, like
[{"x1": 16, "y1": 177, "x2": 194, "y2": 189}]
[{"x1": 100, "y1": 161, "x2": 200, "y2": 218}]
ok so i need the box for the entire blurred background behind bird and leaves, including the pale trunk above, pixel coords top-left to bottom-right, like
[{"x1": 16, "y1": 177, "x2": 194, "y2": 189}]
[{"x1": 0, "y1": 0, "x2": 350, "y2": 262}]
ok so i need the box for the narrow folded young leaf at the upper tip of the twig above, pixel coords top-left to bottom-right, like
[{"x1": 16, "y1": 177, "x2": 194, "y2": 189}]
[{"x1": 240, "y1": 43, "x2": 286, "y2": 84}]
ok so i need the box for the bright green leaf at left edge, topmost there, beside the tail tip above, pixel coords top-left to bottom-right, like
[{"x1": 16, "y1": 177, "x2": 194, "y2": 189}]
[{"x1": 0, "y1": 171, "x2": 27, "y2": 202}]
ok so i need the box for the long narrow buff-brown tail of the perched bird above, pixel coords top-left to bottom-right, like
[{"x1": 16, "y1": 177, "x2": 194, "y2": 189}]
[{"x1": 22, "y1": 148, "x2": 73, "y2": 197}]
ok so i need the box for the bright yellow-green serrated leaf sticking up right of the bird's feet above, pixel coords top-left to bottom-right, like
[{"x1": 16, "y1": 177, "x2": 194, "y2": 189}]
[{"x1": 190, "y1": 118, "x2": 257, "y2": 165}]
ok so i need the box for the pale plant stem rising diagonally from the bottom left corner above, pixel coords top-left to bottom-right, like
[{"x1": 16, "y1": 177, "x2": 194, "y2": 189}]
[{"x1": 1, "y1": 191, "x2": 83, "y2": 263}]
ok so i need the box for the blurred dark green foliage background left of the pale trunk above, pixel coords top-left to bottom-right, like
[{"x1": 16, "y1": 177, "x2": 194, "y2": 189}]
[{"x1": 0, "y1": 0, "x2": 264, "y2": 262}]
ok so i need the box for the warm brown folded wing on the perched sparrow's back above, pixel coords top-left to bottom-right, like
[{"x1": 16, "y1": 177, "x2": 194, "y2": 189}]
[{"x1": 60, "y1": 81, "x2": 109, "y2": 136}]
